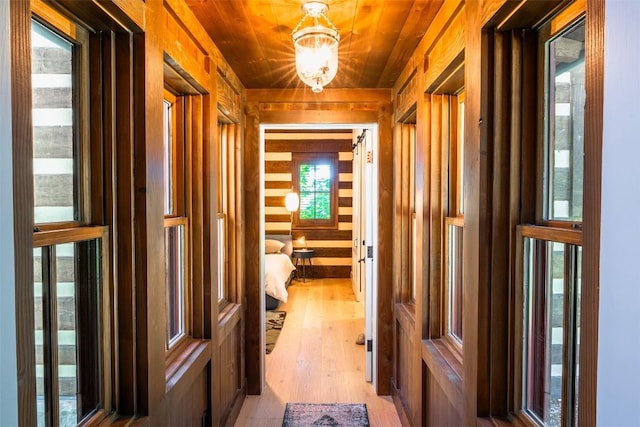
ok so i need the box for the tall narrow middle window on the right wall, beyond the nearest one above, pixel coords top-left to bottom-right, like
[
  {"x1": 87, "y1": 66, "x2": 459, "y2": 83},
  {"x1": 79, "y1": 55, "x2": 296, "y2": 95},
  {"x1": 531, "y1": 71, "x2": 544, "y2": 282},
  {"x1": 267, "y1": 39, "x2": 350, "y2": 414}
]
[{"x1": 443, "y1": 93, "x2": 464, "y2": 346}]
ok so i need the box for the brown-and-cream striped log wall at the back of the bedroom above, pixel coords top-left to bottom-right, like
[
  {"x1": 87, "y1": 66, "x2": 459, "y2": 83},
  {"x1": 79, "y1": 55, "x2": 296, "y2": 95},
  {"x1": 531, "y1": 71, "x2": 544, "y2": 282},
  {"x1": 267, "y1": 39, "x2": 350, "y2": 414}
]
[{"x1": 264, "y1": 129, "x2": 354, "y2": 278}]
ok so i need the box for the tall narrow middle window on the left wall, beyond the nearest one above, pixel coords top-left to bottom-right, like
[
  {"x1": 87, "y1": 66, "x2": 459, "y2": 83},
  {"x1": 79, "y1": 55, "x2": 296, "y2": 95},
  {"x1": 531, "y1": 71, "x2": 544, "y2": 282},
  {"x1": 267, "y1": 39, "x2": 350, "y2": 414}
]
[{"x1": 163, "y1": 91, "x2": 188, "y2": 349}]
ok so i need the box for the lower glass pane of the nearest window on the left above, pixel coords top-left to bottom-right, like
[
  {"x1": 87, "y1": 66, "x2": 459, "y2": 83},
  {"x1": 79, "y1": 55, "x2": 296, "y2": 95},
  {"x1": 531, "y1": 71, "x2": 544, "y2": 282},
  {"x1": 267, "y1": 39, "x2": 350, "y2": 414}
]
[{"x1": 33, "y1": 240, "x2": 102, "y2": 426}]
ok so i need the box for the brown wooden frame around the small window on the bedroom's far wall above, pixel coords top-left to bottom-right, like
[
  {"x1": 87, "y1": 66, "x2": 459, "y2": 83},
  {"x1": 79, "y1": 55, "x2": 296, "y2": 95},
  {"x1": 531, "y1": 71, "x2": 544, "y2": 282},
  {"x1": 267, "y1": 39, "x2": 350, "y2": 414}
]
[{"x1": 291, "y1": 152, "x2": 339, "y2": 230}]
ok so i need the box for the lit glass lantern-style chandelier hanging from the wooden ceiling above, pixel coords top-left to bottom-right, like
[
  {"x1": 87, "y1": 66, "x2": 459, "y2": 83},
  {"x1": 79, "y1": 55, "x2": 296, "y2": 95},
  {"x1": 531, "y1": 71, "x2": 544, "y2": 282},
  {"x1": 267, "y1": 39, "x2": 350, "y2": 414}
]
[{"x1": 291, "y1": 1, "x2": 340, "y2": 93}]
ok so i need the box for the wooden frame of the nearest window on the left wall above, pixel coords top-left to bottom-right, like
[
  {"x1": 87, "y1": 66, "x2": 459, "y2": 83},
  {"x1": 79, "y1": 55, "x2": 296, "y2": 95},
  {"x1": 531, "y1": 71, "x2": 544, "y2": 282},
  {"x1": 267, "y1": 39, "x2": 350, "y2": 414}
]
[{"x1": 28, "y1": 8, "x2": 115, "y2": 425}]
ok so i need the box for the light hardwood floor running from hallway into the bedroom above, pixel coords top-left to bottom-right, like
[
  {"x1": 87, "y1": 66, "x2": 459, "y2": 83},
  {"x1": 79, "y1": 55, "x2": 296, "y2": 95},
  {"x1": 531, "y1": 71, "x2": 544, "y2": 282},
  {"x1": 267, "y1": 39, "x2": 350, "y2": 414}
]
[{"x1": 235, "y1": 279, "x2": 401, "y2": 427}]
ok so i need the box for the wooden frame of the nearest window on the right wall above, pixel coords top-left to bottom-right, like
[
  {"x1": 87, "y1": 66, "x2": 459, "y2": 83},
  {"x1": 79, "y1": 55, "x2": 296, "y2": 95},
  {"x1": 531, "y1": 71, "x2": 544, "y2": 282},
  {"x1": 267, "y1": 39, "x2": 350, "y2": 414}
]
[{"x1": 514, "y1": 8, "x2": 593, "y2": 426}]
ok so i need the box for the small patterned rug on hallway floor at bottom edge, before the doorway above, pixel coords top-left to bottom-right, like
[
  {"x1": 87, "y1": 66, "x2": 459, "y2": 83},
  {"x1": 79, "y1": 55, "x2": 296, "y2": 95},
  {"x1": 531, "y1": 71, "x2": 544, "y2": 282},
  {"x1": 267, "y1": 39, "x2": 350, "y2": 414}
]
[{"x1": 282, "y1": 403, "x2": 369, "y2": 427}]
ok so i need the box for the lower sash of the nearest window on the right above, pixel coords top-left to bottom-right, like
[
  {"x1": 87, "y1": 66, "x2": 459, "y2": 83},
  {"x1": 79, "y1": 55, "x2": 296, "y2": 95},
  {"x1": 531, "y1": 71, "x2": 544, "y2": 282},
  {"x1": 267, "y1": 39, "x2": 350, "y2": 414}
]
[{"x1": 522, "y1": 228, "x2": 582, "y2": 426}]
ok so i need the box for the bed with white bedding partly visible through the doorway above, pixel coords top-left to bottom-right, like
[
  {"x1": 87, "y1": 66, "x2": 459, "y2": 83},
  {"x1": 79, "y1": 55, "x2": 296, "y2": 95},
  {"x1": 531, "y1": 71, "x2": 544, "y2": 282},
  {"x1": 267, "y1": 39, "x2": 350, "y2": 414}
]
[{"x1": 264, "y1": 234, "x2": 296, "y2": 310}]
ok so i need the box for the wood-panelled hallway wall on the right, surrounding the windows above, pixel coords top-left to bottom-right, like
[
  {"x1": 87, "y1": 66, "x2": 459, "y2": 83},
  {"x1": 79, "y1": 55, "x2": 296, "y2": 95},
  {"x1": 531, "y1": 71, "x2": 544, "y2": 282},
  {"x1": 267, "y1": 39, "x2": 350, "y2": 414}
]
[{"x1": 392, "y1": 0, "x2": 599, "y2": 426}]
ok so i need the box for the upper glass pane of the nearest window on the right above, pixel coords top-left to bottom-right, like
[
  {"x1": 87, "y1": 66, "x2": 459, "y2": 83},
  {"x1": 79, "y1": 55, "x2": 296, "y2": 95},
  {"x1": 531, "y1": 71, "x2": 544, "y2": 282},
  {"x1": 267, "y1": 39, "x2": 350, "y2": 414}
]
[{"x1": 545, "y1": 22, "x2": 585, "y2": 222}]
